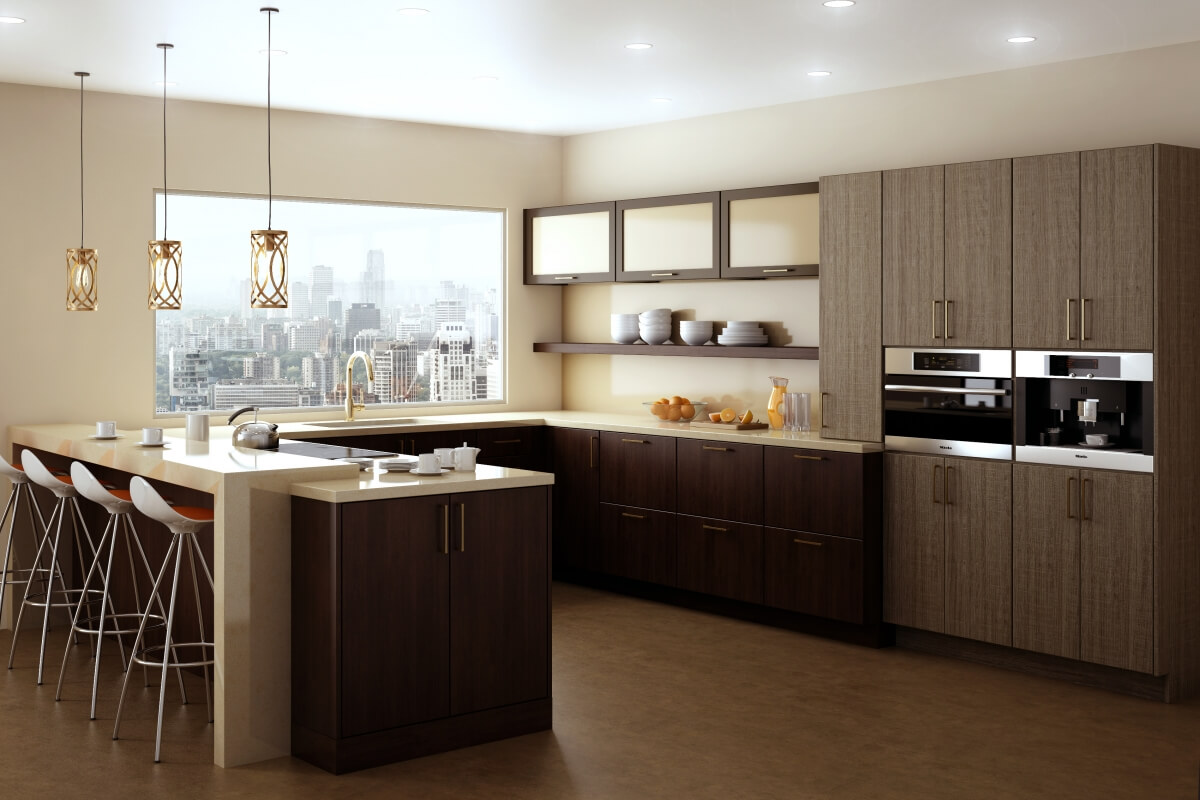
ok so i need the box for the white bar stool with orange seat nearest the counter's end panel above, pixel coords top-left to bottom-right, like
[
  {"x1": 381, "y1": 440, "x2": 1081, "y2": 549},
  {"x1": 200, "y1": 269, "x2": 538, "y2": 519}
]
[{"x1": 113, "y1": 476, "x2": 216, "y2": 763}]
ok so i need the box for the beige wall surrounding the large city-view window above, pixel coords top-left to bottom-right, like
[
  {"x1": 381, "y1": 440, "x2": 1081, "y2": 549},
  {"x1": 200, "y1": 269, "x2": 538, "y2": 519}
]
[{"x1": 0, "y1": 84, "x2": 562, "y2": 453}]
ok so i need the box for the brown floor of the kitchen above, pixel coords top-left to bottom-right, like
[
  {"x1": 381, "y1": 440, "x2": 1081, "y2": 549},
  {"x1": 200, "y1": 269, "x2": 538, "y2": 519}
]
[{"x1": 0, "y1": 584, "x2": 1200, "y2": 800}]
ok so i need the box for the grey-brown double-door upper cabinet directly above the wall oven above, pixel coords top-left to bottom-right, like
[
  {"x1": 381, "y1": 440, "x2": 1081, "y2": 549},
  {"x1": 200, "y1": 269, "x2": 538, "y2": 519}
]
[{"x1": 883, "y1": 158, "x2": 1013, "y2": 348}]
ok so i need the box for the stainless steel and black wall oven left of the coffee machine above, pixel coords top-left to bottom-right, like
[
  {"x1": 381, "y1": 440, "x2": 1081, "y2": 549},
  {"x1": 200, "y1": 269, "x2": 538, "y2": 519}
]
[{"x1": 883, "y1": 348, "x2": 1013, "y2": 459}]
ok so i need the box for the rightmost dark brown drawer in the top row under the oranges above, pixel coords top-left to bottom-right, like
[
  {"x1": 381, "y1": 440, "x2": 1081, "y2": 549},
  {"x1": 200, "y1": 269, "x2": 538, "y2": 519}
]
[{"x1": 763, "y1": 447, "x2": 864, "y2": 539}]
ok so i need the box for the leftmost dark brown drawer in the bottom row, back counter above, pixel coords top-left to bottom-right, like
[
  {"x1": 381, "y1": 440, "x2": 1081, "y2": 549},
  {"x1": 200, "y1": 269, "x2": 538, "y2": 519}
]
[{"x1": 596, "y1": 503, "x2": 676, "y2": 585}]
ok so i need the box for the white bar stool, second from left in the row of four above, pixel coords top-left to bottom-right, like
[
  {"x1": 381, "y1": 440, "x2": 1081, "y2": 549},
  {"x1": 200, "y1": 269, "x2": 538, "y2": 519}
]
[{"x1": 8, "y1": 450, "x2": 102, "y2": 686}]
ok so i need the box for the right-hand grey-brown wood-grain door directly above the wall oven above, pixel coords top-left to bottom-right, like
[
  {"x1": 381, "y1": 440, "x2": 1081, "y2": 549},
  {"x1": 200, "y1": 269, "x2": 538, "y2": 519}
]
[{"x1": 942, "y1": 158, "x2": 1013, "y2": 348}]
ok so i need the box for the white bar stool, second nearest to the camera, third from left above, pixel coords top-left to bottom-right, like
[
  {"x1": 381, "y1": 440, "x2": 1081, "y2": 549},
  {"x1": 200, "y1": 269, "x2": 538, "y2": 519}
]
[{"x1": 54, "y1": 462, "x2": 187, "y2": 720}]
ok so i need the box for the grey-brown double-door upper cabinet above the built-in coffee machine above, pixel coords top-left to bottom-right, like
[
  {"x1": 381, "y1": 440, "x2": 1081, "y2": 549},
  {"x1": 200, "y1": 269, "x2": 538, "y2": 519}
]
[{"x1": 1013, "y1": 145, "x2": 1154, "y2": 350}]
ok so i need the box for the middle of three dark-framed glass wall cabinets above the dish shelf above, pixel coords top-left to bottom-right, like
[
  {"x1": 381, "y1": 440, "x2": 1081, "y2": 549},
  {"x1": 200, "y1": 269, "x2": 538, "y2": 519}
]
[{"x1": 617, "y1": 192, "x2": 721, "y2": 281}]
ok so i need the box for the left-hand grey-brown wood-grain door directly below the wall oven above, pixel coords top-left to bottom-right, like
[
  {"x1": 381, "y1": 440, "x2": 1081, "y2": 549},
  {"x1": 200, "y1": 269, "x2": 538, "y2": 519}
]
[{"x1": 883, "y1": 453, "x2": 946, "y2": 633}]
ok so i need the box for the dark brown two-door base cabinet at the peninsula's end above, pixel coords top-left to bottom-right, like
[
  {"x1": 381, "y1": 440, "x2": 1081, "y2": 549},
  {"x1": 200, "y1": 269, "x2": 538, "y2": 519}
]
[{"x1": 292, "y1": 487, "x2": 551, "y2": 772}]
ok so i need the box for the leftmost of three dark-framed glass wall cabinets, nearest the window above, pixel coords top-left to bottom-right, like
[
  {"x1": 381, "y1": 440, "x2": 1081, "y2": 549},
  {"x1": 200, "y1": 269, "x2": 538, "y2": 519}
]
[{"x1": 524, "y1": 203, "x2": 617, "y2": 285}]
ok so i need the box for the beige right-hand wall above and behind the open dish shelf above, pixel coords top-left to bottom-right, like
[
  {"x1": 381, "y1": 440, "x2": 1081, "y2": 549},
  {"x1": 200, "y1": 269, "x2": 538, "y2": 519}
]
[{"x1": 563, "y1": 43, "x2": 1200, "y2": 414}]
